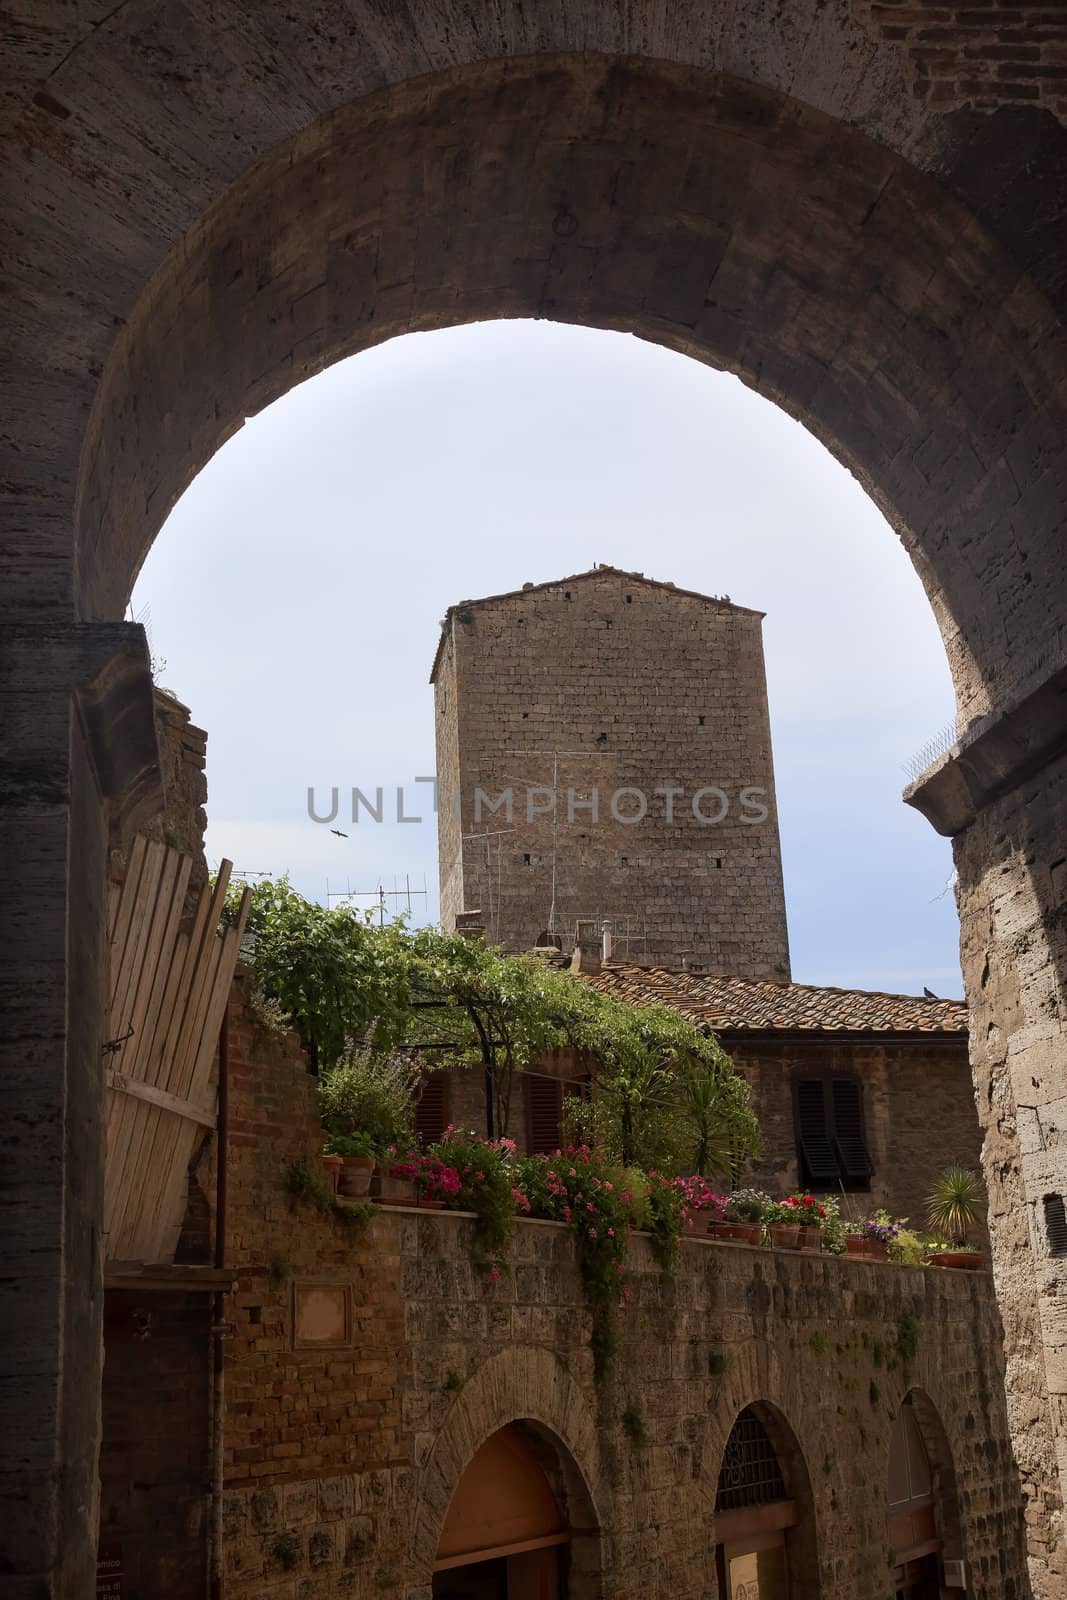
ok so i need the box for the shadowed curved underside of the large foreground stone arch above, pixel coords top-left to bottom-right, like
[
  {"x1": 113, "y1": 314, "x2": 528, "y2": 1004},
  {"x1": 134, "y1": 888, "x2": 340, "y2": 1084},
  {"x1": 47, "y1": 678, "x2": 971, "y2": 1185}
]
[{"x1": 75, "y1": 56, "x2": 1067, "y2": 732}]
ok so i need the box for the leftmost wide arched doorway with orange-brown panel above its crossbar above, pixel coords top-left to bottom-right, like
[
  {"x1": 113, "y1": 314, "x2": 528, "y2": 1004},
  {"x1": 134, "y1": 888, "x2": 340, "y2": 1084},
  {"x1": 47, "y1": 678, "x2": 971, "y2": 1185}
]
[{"x1": 432, "y1": 1422, "x2": 577, "y2": 1600}]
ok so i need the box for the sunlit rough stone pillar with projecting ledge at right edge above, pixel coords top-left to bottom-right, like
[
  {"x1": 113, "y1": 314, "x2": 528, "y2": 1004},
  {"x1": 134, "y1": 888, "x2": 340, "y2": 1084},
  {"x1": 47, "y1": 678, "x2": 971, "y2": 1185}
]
[{"x1": 905, "y1": 669, "x2": 1067, "y2": 1600}]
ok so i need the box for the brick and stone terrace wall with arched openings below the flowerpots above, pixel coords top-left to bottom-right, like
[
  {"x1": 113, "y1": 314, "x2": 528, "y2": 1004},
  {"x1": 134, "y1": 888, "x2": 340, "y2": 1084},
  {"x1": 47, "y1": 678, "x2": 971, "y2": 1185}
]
[{"x1": 194, "y1": 986, "x2": 1036, "y2": 1600}]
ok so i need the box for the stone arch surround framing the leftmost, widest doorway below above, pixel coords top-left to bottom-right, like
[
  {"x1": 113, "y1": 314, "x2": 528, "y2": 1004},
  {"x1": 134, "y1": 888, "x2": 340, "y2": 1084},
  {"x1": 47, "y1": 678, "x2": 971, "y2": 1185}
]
[{"x1": 411, "y1": 1346, "x2": 606, "y2": 1595}]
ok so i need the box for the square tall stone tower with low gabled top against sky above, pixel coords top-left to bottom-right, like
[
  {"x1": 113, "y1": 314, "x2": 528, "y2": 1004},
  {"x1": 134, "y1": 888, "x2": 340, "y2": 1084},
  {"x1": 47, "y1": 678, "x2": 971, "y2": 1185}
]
[{"x1": 430, "y1": 566, "x2": 789, "y2": 978}]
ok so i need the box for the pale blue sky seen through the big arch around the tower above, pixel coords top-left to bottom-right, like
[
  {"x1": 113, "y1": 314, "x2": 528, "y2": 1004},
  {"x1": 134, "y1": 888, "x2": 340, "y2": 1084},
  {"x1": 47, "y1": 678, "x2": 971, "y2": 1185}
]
[{"x1": 133, "y1": 322, "x2": 961, "y2": 995}]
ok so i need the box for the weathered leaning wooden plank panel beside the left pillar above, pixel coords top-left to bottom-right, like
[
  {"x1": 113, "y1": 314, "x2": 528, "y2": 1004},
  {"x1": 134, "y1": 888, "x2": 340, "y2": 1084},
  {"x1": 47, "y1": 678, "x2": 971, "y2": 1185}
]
[{"x1": 104, "y1": 838, "x2": 250, "y2": 1264}]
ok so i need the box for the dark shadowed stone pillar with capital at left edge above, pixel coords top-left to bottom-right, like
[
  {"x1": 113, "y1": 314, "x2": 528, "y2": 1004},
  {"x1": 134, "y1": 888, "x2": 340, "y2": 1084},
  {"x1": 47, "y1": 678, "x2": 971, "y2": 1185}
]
[{"x1": 0, "y1": 624, "x2": 158, "y2": 1600}]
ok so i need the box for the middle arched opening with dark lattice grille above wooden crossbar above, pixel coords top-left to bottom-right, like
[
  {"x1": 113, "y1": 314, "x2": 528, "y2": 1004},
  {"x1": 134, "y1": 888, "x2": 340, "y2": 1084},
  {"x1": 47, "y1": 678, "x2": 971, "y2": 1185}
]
[{"x1": 715, "y1": 1406, "x2": 797, "y2": 1600}]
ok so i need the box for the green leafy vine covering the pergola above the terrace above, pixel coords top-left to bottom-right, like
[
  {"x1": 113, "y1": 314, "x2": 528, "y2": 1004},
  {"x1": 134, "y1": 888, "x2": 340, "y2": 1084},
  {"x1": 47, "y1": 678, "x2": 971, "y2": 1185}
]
[{"x1": 227, "y1": 878, "x2": 760, "y2": 1181}]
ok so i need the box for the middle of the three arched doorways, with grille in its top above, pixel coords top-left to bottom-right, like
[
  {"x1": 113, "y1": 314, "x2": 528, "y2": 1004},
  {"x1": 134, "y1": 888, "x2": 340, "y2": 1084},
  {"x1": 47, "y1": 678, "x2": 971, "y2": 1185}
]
[{"x1": 715, "y1": 1405, "x2": 817, "y2": 1600}]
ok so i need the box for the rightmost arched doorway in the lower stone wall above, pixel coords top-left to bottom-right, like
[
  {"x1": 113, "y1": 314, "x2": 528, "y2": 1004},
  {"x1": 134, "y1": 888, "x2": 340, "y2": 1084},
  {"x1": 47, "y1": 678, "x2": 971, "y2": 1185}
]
[{"x1": 888, "y1": 1390, "x2": 965, "y2": 1600}]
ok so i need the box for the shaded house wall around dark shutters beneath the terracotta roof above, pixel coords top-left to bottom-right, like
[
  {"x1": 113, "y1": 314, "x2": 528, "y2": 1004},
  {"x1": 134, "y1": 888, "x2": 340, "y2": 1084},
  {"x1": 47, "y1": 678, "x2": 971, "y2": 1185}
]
[{"x1": 735, "y1": 1034, "x2": 982, "y2": 1230}]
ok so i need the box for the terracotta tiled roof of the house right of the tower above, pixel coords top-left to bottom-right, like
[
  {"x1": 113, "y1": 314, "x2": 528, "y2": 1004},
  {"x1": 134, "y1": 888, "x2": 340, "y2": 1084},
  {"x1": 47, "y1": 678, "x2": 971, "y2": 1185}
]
[{"x1": 582, "y1": 963, "x2": 966, "y2": 1034}]
